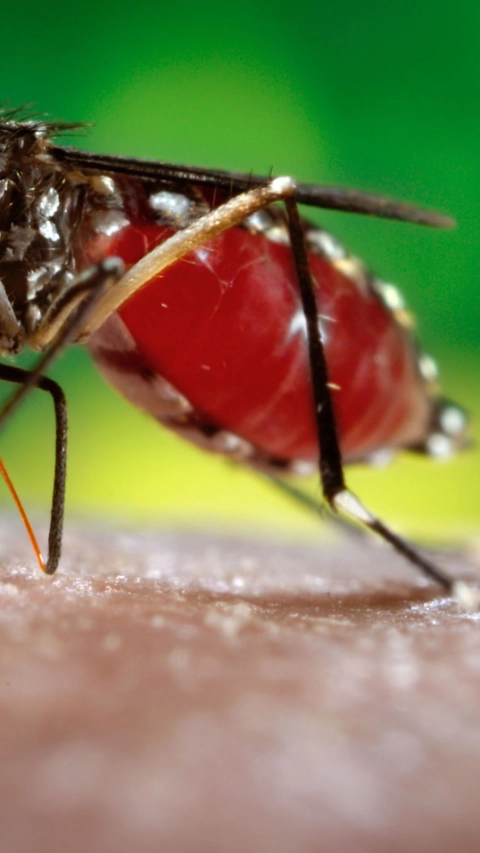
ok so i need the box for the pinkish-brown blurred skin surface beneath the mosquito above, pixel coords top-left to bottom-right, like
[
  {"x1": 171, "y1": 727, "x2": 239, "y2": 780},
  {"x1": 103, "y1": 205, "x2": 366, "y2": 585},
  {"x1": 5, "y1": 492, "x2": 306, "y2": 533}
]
[{"x1": 0, "y1": 521, "x2": 480, "y2": 853}]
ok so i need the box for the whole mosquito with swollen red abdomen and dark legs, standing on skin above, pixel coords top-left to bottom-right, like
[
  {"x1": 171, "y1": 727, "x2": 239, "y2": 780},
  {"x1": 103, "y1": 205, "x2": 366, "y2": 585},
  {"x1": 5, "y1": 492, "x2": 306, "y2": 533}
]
[{"x1": 0, "y1": 111, "x2": 466, "y2": 593}]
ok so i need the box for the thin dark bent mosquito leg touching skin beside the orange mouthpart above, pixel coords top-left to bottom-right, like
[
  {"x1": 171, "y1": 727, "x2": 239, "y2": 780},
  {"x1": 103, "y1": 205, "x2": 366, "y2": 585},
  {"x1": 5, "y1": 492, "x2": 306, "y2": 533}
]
[{"x1": 0, "y1": 364, "x2": 67, "y2": 575}]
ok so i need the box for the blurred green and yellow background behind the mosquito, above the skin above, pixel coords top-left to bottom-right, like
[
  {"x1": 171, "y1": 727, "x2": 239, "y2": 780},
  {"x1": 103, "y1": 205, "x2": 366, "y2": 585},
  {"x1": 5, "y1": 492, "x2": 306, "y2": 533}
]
[{"x1": 0, "y1": 0, "x2": 480, "y2": 541}]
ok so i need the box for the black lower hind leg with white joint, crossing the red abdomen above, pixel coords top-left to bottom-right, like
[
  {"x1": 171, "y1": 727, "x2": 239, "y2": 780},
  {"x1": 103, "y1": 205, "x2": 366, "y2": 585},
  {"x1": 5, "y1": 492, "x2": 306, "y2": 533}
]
[{"x1": 285, "y1": 197, "x2": 463, "y2": 595}]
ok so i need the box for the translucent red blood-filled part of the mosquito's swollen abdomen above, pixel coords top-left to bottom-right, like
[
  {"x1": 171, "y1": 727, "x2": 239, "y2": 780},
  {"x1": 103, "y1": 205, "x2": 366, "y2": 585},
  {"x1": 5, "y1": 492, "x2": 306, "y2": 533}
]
[{"x1": 85, "y1": 216, "x2": 429, "y2": 461}]
